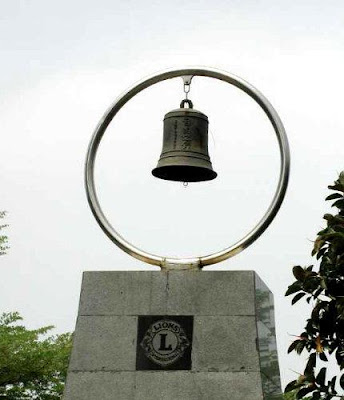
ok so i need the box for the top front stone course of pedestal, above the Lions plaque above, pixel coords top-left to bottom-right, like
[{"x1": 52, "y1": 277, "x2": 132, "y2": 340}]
[{"x1": 79, "y1": 271, "x2": 255, "y2": 316}]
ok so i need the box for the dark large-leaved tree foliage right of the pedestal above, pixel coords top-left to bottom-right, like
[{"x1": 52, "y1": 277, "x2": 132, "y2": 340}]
[{"x1": 285, "y1": 172, "x2": 344, "y2": 400}]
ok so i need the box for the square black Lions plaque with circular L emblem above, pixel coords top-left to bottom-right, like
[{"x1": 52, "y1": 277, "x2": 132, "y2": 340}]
[{"x1": 136, "y1": 315, "x2": 193, "y2": 371}]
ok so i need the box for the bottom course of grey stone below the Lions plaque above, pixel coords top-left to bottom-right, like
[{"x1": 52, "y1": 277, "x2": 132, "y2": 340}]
[{"x1": 64, "y1": 371, "x2": 263, "y2": 400}]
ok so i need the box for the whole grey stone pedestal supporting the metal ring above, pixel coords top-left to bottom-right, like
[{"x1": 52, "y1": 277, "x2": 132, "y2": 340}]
[{"x1": 64, "y1": 271, "x2": 281, "y2": 400}]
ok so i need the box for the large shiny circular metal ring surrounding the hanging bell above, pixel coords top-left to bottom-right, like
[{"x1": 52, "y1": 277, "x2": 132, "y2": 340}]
[{"x1": 85, "y1": 67, "x2": 290, "y2": 269}]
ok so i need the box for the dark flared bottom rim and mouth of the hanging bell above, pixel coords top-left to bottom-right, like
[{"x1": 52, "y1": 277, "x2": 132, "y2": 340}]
[{"x1": 152, "y1": 165, "x2": 217, "y2": 182}]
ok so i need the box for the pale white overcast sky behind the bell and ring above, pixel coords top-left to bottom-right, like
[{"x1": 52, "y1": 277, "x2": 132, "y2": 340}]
[{"x1": 0, "y1": 0, "x2": 344, "y2": 390}]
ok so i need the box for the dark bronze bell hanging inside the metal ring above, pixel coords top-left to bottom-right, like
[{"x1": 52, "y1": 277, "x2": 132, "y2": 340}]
[{"x1": 152, "y1": 99, "x2": 217, "y2": 182}]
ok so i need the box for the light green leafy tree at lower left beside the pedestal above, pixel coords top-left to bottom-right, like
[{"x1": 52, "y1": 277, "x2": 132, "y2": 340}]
[{"x1": 0, "y1": 312, "x2": 72, "y2": 400}]
